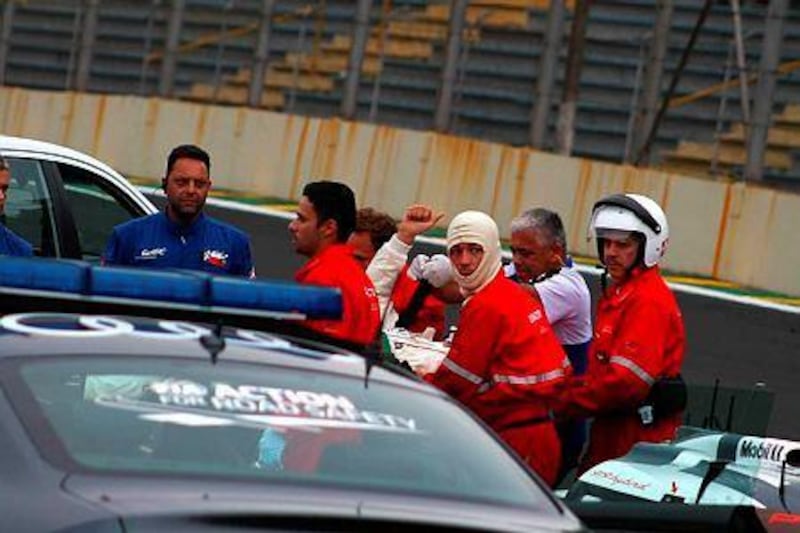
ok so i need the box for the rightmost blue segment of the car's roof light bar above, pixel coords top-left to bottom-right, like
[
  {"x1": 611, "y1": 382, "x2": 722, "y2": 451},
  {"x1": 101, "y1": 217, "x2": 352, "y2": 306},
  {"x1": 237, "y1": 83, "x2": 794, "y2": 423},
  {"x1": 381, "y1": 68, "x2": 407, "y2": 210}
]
[{"x1": 211, "y1": 276, "x2": 342, "y2": 318}]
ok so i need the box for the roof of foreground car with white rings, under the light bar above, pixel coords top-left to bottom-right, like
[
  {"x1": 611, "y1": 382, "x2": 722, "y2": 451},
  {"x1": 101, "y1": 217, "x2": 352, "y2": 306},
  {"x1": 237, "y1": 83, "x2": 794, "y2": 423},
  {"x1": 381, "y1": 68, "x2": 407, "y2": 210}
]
[{"x1": 0, "y1": 313, "x2": 444, "y2": 390}]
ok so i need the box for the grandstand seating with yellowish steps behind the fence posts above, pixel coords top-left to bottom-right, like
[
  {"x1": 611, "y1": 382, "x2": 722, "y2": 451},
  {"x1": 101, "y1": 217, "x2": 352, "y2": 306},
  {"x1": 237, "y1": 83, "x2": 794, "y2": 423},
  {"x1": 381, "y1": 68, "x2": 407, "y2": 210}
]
[{"x1": 0, "y1": 0, "x2": 800, "y2": 184}]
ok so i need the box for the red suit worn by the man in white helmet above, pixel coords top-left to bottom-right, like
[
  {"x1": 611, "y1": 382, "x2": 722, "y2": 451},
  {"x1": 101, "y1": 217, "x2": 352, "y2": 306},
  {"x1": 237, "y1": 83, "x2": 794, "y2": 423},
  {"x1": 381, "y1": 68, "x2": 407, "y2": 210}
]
[{"x1": 557, "y1": 267, "x2": 686, "y2": 472}]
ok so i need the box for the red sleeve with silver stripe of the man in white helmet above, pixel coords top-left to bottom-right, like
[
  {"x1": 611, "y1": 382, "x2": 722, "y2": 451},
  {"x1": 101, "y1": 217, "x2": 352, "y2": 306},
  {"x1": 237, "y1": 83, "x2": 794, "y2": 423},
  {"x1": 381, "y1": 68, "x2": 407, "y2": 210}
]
[{"x1": 557, "y1": 301, "x2": 669, "y2": 417}]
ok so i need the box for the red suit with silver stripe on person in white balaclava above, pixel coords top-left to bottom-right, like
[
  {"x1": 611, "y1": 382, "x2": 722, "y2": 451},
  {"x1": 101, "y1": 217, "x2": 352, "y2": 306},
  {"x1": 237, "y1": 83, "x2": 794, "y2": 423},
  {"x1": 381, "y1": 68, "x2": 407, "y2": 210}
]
[{"x1": 430, "y1": 272, "x2": 571, "y2": 485}]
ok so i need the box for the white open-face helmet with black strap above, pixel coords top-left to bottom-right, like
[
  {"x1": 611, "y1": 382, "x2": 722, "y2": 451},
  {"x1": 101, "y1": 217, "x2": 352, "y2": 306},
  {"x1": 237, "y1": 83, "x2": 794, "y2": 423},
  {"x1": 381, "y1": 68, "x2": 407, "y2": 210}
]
[{"x1": 589, "y1": 194, "x2": 669, "y2": 268}]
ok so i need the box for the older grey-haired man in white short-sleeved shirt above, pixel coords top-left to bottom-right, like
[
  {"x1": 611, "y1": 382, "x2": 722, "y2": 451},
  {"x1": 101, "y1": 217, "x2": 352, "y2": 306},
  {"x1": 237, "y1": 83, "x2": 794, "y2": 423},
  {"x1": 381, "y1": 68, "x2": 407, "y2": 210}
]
[{"x1": 505, "y1": 208, "x2": 592, "y2": 482}]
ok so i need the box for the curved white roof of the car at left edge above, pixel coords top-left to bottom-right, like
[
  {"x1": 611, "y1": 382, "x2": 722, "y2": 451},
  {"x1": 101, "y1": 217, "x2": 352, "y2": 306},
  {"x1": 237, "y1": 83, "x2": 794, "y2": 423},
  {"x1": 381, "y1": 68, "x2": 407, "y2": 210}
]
[{"x1": 0, "y1": 135, "x2": 158, "y2": 213}]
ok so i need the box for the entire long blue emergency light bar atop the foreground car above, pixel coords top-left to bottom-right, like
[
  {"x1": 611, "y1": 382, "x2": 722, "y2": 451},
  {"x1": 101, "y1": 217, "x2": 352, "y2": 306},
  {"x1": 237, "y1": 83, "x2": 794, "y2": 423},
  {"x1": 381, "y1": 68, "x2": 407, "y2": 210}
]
[{"x1": 0, "y1": 256, "x2": 342, "y2": 319}]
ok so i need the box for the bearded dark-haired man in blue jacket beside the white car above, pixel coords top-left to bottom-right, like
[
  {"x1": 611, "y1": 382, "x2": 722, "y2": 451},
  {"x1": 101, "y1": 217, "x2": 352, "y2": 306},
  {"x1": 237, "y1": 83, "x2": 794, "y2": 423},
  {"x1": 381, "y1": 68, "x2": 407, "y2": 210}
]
[{"x1": 103, "y1": 144, "x2": 255, "y2": 278}]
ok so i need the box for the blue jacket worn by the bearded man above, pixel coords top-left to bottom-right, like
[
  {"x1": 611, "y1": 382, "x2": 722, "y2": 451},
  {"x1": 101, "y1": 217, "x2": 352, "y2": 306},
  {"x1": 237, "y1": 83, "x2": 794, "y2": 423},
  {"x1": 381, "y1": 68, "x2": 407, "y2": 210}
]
[{"x1": 103, "y1": 212, "x2": 254, "y2": 277}]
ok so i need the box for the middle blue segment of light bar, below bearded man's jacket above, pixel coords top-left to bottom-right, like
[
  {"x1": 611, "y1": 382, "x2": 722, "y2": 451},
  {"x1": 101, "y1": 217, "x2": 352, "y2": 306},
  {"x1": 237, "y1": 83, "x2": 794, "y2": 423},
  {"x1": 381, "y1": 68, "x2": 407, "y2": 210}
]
[{"x1": 89, "y1": 267, "x2": 210, "y2": 305}]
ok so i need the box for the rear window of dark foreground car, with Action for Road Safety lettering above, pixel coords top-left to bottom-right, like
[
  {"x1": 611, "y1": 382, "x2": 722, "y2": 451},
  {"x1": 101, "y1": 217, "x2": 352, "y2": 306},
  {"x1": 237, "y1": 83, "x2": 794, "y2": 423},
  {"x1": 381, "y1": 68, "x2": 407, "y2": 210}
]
[{"x1": 3, "y1": 356, "x2": 553, "y2": 509}]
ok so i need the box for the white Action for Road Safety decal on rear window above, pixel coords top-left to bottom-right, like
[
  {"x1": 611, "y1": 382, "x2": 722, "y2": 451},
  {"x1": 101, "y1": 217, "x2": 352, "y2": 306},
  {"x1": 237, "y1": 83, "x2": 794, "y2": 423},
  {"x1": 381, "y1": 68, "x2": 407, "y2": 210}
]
[{"x1": 94, "y1": 376, "x2": 421, "y2": 433}]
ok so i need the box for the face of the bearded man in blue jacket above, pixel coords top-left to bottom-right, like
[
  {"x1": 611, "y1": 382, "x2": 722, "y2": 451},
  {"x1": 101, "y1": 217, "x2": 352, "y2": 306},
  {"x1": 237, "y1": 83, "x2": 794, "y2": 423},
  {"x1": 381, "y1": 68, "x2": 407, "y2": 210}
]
[{"x1": 164, "y1": 157, "x2": 211, "y2": 220}]
